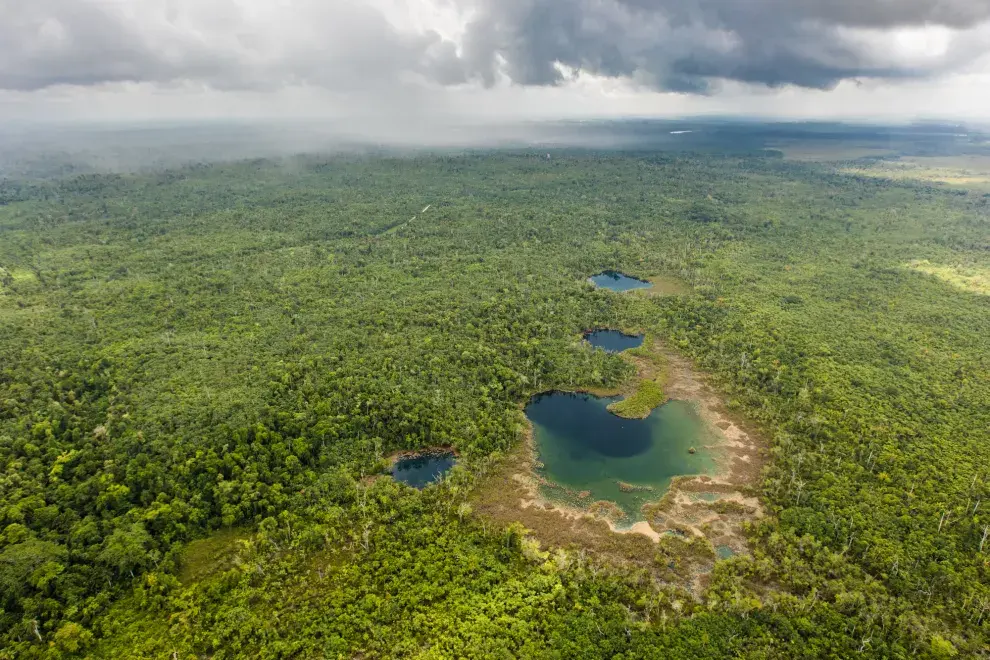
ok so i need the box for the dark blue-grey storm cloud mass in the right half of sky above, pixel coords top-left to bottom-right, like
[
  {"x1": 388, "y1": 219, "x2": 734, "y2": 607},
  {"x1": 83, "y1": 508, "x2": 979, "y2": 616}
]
[{"x1": 465, "y1": 0, "x2": 990, "y2": 92}]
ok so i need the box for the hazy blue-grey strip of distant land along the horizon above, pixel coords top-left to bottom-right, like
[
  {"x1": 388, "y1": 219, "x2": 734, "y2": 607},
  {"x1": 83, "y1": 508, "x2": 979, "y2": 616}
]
[{"x1": 0, "y1": 117, "x2": 990, "y2": 178}]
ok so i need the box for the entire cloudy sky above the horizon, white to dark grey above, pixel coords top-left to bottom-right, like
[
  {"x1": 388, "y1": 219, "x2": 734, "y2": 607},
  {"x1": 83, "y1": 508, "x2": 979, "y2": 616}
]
[{"x1": 0, "y1": 0, "x2": 990, "y2": 123}]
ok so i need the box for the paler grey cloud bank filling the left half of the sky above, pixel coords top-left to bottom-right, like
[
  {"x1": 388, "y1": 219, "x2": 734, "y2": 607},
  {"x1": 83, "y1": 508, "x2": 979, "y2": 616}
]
[{"x1": 0, "y1": 0, "x2": 466, "y2": 91}]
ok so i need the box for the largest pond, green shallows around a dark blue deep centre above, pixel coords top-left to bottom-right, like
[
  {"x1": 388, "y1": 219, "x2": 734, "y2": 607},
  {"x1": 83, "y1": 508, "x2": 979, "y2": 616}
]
[{"x1": 526, "y1": 392, "x2": 716, "y2": 522}]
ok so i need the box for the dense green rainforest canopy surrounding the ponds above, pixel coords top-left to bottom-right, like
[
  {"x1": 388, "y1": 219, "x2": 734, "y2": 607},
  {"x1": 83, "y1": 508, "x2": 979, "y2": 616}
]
[{"x1": 0, "y1": 150, "x2": 990, "y2": 658}]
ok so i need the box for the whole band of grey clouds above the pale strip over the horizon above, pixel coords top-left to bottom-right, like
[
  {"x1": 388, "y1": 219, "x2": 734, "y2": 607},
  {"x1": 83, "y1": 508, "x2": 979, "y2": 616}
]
[{"x1": 0, "y1": 0, "x2": 990, "y2": 93}]
